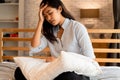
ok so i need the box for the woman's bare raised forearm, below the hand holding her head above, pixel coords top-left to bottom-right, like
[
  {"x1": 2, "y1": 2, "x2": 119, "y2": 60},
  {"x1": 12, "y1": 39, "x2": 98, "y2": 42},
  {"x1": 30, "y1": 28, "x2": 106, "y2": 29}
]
[{"x1": 31, "y1": 21, "x2": 43, "y2": 47}]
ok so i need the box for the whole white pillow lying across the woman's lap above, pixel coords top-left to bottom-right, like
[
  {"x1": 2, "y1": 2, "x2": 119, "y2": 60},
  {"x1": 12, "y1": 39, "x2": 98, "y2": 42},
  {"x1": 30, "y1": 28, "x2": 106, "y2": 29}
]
[{"x1": 14, "y1": 51, "x2": 102, "y2": 80}]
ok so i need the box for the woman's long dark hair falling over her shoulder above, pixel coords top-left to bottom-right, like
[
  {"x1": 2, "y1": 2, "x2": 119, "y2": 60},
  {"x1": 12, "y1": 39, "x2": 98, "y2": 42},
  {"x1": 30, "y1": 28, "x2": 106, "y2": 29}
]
[{"x1": 40, "y1": 0, "x2": 74, "y2": 43}]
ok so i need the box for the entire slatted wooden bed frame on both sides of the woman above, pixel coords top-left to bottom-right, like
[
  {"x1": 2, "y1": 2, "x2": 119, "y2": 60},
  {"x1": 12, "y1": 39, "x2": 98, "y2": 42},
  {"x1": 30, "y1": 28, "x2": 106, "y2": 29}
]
[{"x1": 0, "y1": 28, "x2": 120, "y2": 63}]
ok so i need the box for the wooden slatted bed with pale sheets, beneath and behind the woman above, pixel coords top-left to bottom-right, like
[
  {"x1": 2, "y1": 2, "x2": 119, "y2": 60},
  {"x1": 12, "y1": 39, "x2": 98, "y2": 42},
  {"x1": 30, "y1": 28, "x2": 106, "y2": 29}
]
[{"x1": 0, "y1": 29, "x2": 120, "y2": 80}]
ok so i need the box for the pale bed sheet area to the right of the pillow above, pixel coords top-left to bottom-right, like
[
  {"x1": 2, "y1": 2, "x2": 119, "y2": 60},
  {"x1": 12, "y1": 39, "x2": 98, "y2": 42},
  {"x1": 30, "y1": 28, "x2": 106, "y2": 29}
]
[{"x1": 91, "y1": 66, "x2": 120, "y2": 80}]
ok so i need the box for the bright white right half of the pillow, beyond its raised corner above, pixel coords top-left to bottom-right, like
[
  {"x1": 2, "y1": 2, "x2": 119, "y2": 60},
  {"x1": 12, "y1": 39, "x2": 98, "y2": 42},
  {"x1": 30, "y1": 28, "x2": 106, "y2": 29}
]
[{"x1": 60, "y1": 51, "x2": 102, "y2": 76}]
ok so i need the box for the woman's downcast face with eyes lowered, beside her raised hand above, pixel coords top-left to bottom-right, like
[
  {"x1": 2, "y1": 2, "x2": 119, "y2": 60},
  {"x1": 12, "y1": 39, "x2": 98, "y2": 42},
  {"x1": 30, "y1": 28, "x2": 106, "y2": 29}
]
[{"x1": 43, "y1": 6, "x2": 61, "y2": 26}]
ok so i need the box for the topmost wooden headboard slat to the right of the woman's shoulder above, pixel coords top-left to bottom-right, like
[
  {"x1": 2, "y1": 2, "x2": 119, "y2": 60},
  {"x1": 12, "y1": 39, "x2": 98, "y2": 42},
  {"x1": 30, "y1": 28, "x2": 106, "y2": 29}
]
[{"x1": 88, "y1": 29, "x2": 120, "y2": 33}]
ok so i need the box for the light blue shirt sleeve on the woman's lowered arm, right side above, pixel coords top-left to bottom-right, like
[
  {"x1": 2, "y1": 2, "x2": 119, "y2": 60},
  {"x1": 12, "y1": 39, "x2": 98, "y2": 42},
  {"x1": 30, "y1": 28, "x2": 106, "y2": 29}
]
[{"x1": 75, "y1": 24, "x2": 95, "y2": 58}]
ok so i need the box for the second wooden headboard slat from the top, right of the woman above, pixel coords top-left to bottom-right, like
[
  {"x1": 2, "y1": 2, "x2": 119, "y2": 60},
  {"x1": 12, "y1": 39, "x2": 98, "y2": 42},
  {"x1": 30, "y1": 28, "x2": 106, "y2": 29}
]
[{"x1": 91, "y1": 39, "x2": 120, "y2": 43}]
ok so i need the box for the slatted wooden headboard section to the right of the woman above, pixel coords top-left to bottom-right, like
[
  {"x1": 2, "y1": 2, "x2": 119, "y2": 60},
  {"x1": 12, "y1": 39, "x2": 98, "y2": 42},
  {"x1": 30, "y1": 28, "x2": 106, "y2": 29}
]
[{"x1": 88, "y1": 29, "x2": 120, "y2": 63}]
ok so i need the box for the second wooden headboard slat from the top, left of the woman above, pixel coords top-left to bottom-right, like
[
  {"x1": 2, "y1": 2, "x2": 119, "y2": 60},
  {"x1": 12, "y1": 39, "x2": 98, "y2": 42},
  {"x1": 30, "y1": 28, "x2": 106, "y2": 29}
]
[{"x1": 2, "y1": 37, "x2": 32, "y2": 41}]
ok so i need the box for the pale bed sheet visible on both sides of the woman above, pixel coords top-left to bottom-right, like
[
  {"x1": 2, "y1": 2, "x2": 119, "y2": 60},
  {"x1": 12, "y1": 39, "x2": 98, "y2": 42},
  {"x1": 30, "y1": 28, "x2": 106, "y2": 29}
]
[{"x1": 0, "y1": 62, "x2": 120, "y2": 80}]
